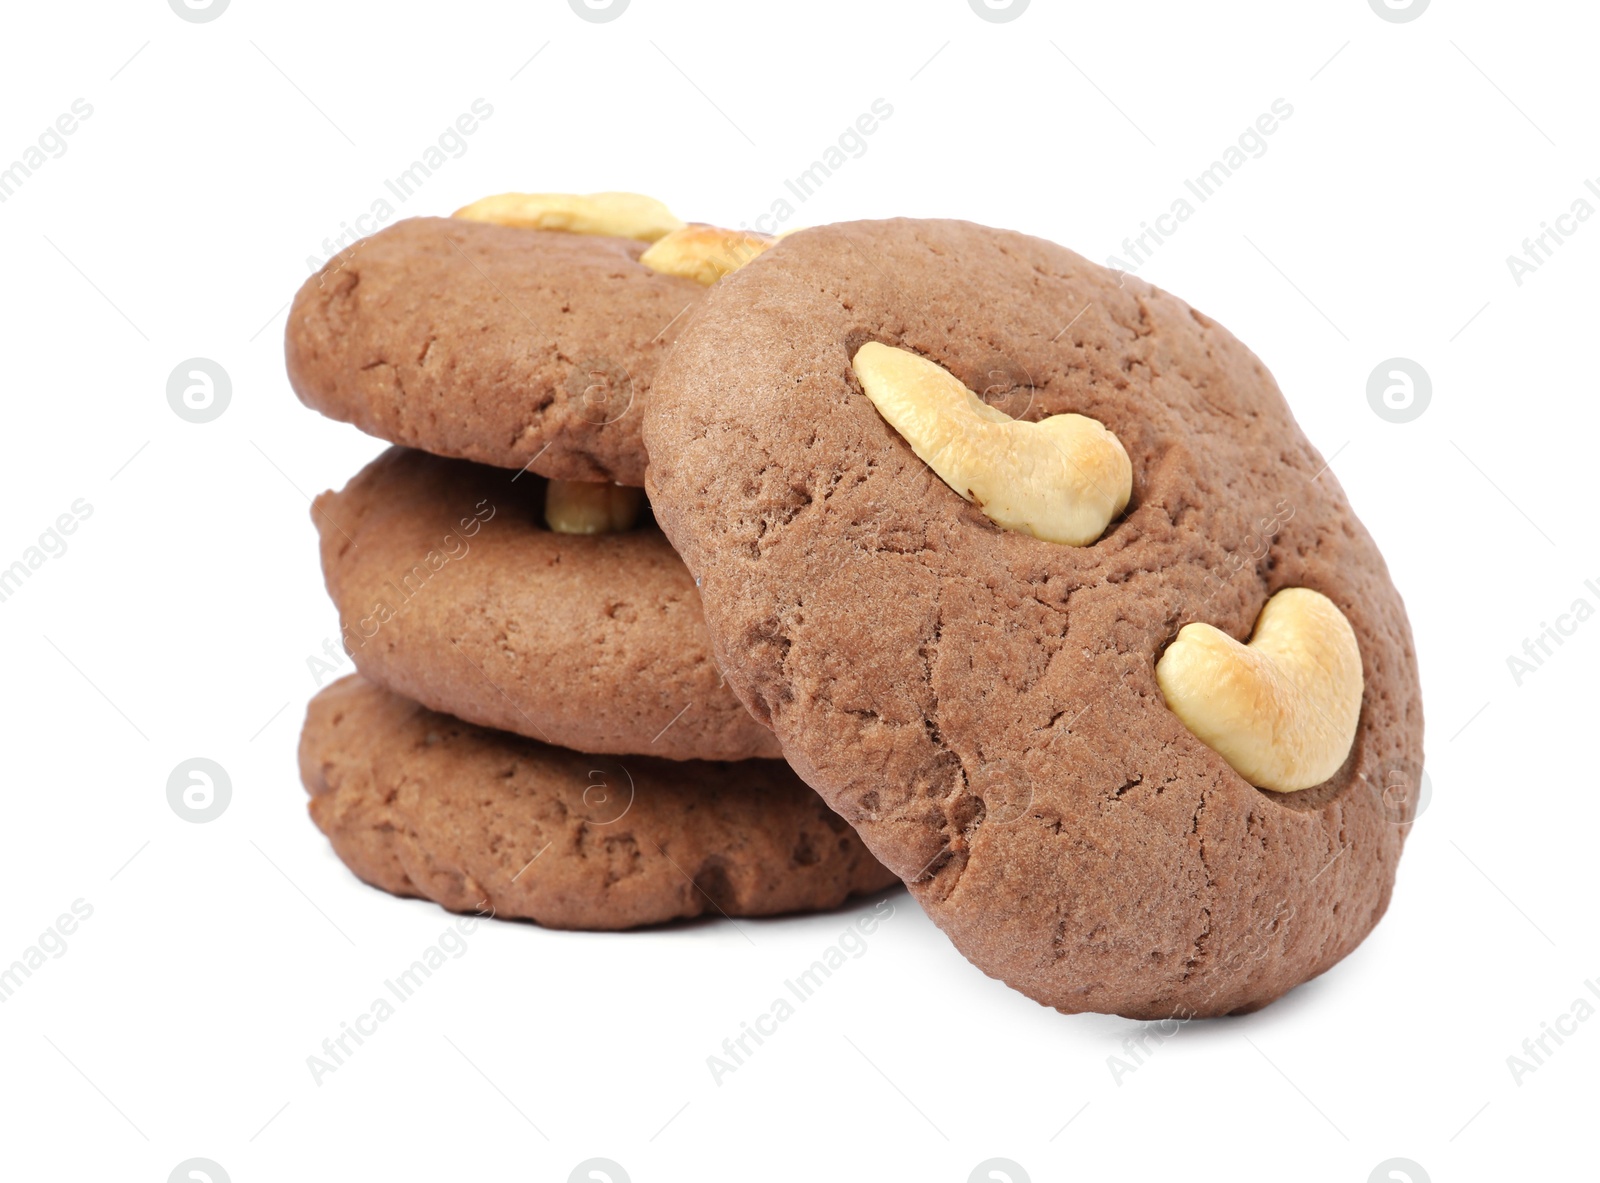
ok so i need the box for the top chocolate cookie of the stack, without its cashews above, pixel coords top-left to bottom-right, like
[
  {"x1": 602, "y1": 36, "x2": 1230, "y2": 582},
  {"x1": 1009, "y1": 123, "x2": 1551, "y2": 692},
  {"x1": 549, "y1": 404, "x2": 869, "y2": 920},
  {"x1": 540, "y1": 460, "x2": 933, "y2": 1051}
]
[{"x1": 285, "y1": 218, "x2": 706, "y2": 485}]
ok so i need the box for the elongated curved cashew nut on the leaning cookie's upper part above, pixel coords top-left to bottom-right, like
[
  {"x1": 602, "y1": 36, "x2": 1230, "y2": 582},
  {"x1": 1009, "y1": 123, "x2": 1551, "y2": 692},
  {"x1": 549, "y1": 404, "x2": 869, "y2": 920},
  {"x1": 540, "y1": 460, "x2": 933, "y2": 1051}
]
[{"x1": 851, "y1": 341, "x2": 1133, "y2": 546}]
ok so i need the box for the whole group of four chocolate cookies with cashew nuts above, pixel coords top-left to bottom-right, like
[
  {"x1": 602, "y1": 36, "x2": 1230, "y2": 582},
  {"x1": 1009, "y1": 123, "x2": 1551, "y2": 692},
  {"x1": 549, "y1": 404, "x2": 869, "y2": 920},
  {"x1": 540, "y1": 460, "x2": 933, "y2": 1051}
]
[{"x1": 288, "y1": 195, "x2": 1422, "y2": 1018}]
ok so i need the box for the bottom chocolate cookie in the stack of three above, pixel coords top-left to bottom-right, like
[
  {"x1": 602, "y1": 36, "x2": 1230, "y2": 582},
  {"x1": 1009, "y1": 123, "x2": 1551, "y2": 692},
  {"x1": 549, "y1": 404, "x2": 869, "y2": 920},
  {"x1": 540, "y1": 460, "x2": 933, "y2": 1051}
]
[{"x1": 299, "y1": 676, "x2": 894, "y2": 928}]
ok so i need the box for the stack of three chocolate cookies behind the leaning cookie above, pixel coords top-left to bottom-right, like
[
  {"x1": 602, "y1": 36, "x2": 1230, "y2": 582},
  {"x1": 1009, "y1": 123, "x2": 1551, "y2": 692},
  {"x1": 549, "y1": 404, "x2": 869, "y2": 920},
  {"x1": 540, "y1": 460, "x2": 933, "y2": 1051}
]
[{"x1": 286, "y1": 194, "x2": 894, "y2": 928}]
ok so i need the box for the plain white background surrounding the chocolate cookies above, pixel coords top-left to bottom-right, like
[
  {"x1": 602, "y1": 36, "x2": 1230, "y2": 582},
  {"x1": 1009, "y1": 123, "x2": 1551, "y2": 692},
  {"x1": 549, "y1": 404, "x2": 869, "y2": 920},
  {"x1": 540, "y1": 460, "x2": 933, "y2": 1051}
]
[{"x1": 0, "y1": 0, "x2": 1600, "y2": 1183}]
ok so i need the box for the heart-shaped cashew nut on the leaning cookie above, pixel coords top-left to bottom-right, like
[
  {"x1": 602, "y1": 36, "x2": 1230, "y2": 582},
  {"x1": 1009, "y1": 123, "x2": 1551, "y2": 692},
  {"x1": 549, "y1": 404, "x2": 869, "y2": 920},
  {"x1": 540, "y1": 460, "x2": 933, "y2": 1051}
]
[{"x1": 1155, "y1": 587, "x2": 1362, "y2": 792}]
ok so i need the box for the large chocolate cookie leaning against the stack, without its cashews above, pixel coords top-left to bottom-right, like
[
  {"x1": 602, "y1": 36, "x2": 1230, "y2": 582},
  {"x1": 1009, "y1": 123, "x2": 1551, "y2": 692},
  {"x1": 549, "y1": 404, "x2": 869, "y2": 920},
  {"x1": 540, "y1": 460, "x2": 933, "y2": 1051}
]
[{"x1": 645, "y1": 219, "x2": 1422, "y2": 1018}]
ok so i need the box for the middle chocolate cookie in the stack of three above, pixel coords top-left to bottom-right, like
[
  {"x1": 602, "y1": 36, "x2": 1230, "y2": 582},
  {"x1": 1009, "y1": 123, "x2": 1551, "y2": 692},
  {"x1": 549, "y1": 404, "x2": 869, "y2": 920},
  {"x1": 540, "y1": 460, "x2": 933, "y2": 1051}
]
[{"x1": 312, "y1": 448, "x2": 779, "y2": 760}]
